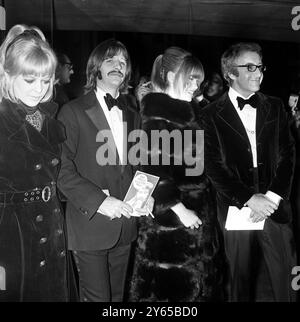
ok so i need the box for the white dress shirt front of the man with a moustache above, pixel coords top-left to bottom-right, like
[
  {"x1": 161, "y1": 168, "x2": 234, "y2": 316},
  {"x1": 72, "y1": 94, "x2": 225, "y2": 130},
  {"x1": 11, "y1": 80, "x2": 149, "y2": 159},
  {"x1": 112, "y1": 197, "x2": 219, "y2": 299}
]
[{"x1": 95, "y1": 87, "x2": 124, "y2": 164}]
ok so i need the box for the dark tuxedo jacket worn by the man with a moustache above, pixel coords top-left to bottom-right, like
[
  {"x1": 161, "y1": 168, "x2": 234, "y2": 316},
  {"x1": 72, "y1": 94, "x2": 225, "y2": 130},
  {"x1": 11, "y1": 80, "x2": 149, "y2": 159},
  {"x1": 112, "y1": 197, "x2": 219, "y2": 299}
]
[{"x1": 58, "y1": 91, "x2": 139, "y2": 250}]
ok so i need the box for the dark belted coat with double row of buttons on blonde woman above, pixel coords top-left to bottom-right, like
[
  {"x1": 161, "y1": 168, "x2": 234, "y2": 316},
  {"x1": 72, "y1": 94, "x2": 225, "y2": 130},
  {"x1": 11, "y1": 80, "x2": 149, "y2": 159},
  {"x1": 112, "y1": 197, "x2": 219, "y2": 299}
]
[{"x1": 0, "y1": 100, "x2": 67, "y2": 302}]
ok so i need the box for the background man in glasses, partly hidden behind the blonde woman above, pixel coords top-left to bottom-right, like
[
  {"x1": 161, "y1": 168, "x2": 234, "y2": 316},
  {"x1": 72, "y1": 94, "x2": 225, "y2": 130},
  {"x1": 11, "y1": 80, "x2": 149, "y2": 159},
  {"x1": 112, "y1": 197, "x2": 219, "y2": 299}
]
[{"x1": 54, "y1": 52, "x2": 74, "y2": 109}]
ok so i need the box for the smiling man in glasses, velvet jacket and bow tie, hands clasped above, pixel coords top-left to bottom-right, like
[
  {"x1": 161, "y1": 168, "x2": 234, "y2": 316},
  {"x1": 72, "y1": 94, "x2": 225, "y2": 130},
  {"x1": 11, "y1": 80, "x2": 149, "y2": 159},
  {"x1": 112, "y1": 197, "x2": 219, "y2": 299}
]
[{"x1": 203, "y1": 43, "x2": 296, "y2": 302}]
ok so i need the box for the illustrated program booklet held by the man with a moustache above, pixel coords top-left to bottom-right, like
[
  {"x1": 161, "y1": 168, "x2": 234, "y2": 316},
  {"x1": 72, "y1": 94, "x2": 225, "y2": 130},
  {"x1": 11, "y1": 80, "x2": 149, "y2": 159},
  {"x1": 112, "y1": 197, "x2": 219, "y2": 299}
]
[{"x1": 124, "y1": 171, "x2": 159, "y2": 217}]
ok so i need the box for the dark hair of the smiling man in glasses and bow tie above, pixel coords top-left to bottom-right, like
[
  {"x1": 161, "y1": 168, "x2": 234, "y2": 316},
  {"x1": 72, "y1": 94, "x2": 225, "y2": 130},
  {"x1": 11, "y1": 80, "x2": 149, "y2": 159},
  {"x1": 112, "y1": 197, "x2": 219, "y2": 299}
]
[{"x1": 221, "y1": 42, "x2": 262, "y2": 84}]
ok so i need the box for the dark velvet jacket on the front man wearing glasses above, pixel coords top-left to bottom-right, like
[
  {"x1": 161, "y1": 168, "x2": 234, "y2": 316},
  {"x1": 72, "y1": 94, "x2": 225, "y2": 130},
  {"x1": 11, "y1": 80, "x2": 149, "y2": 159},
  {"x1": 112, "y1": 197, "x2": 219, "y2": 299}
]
[{"x1": 202, "y1": 93, "x2": 295, "y2": 223}]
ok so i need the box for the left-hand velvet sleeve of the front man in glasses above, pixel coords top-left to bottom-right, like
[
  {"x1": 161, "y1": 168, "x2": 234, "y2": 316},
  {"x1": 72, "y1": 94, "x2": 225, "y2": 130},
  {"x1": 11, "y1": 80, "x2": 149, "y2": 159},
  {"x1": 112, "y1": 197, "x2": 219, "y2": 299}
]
[{"x1": 202, "y1": 112, "x2": 253, "y2": 208}]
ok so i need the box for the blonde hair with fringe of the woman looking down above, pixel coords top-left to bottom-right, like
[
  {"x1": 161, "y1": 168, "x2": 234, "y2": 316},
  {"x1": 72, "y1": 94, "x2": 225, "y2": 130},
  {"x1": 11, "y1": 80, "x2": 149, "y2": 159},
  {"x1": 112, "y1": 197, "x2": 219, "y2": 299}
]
[{"x1": 0, "y1": 25, "x2": 57, "y2": 103}]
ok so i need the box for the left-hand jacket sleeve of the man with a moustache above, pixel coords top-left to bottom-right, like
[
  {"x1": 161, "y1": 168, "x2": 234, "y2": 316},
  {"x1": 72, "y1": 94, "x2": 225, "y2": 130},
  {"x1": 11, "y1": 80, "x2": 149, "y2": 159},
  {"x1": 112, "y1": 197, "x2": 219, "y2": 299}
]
[{"x1": 58, "y1": 104, "x2": 107, "y2": 219}]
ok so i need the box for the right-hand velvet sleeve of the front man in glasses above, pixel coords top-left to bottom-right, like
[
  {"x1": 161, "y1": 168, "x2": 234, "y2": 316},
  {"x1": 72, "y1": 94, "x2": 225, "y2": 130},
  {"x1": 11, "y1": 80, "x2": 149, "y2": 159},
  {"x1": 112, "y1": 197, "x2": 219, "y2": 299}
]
[{"x1": 269, "y1": 101, "x2": 295, "y2": 199}]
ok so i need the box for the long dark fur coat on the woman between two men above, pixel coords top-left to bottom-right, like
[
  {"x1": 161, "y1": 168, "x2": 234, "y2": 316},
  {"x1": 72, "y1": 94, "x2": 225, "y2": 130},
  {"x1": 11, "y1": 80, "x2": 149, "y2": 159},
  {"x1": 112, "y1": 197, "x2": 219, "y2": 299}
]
[{"x1": 129, "y1": 93, "x2": 222, "y2": 302}]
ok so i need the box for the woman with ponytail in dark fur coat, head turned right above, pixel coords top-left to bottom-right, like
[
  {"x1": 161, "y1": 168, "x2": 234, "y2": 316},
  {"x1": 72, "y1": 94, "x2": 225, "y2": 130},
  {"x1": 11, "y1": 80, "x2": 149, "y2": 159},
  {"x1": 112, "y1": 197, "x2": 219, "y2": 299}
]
[{"x1": 129, "y1": 47, "x2": 222, "y2": 302}]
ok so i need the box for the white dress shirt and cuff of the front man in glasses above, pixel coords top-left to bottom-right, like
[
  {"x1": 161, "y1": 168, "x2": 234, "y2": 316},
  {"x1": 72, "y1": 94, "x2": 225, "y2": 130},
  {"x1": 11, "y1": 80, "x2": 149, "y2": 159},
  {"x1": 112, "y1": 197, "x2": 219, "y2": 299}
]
[{"x1": 228, "y1": 87, "x2": 282, "y2": 205}]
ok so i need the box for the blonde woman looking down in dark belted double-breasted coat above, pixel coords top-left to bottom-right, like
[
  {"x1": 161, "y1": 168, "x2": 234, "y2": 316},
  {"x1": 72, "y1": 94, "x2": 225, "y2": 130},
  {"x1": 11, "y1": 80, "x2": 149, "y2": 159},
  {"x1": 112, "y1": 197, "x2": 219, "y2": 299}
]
[{"x1": 0, "y1": 25, "x2": 69, "y2": 302}]
